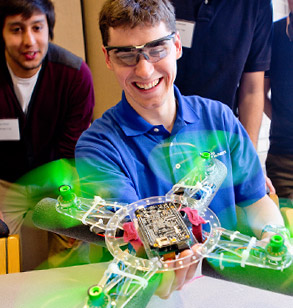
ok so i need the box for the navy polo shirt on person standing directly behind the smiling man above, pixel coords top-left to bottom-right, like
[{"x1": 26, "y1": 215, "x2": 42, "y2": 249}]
[{"x1": 172, "y1": 0, "x2": 272, "y2": 111}]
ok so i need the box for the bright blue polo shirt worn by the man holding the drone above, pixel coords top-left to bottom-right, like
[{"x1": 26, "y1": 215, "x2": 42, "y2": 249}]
[{"x1": 76, "y1": 87, "x2": 265, "y2": 229}]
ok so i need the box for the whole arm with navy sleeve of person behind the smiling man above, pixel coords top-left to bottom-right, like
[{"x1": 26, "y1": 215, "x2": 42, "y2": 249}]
[{"x1": 238, "y1": 0, "x2": 273, "y2": 148}]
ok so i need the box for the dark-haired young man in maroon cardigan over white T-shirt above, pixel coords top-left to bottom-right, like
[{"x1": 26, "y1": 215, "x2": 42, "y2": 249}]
[{"x1": 0, "y1": 0, "x2": 94, "y2": 268}]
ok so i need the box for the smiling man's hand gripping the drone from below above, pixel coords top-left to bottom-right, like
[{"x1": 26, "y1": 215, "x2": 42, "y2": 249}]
[{"x1": 155, "y1": 244, "x2": 202, "y2": 299}]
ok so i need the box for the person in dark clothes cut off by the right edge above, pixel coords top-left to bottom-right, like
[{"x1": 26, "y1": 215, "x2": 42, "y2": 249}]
[{"x1": 265, "y1": 0, "x2": 293, "y2": 202}]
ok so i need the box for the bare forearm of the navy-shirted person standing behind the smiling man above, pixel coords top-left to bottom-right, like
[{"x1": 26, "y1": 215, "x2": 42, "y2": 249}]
[{"x1": 238, "y1": 72, "x2": 264, "y2": 148}]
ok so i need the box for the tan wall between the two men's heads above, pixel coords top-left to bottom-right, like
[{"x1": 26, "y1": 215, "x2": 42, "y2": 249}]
[{"x1": 54, "y1": 0, "x2": 121, "y2": 119}]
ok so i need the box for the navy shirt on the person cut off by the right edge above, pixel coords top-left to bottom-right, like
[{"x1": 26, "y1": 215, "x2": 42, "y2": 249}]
[{"x1": 267, "y1": 18, "x2": 293, "y2": 155}]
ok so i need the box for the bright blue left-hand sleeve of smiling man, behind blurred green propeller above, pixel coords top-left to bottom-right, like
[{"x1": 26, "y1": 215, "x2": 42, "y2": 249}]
[{"x1": 75, "y1": 124, "x2": 139, "y2": 203}]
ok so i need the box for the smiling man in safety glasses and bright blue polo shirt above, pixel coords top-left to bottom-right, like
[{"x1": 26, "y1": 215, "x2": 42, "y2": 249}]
[{"x1": 75, "y1": 0, "x2": 283, "y2": 297}]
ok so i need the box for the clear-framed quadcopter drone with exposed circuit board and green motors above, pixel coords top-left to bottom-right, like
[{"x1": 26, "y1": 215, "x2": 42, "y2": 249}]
[{"x1": 56, "y1": 152, "x2": 292, "y2": 308}]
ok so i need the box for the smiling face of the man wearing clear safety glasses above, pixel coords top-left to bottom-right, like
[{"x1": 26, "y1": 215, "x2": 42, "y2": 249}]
[{"x1": 103, "y1": 23, "x2": 181, "y2": 115}]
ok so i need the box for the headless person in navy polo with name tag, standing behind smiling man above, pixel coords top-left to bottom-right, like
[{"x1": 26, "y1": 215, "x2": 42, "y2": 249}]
[{"x1": 172, "y1": 0, "x2": 276, "y2": 194}]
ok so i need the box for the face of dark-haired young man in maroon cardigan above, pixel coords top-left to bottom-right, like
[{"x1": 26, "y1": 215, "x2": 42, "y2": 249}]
[{"x1": 2, "y1": 13, "x2": 49, "y2": 78}]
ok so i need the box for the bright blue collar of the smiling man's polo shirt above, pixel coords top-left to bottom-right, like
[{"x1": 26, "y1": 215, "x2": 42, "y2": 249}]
[{"x1": 115, "y1": 85, "x2": 199, "y2": 137}]
